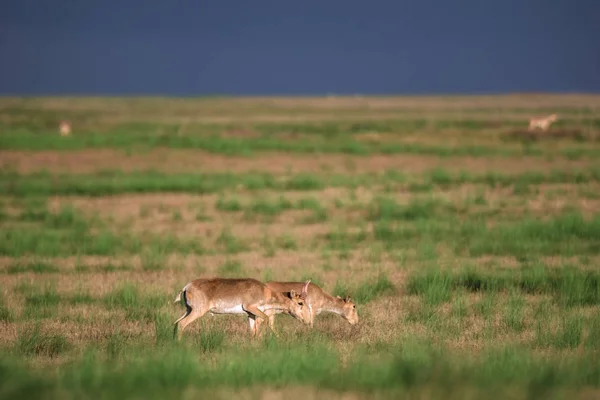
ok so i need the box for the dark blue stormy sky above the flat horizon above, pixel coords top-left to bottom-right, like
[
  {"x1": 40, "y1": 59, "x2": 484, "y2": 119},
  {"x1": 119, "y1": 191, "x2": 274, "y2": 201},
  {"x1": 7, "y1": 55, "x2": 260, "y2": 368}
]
[{"x1": 0, "y1": 0, "x2": 600, "y2": 95}]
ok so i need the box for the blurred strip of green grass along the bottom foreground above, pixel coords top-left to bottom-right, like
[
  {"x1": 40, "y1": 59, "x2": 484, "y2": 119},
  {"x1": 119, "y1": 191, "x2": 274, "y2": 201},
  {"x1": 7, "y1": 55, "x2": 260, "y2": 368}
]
[{"x1": 0, "y1": 337, "x2": 600, "y2": 398}]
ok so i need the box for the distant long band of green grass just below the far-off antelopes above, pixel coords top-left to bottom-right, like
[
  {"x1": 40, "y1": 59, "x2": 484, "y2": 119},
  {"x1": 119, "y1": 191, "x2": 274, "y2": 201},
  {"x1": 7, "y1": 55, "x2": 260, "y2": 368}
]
[{"x1": 0, "y1": 120, "x2": 598, "y2": 157}]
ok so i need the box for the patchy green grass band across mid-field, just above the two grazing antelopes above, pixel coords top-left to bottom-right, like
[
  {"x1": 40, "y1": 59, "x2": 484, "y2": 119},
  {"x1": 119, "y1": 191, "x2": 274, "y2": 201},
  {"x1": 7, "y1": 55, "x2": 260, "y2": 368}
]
[{"x1": 0, "y1": 196, "x2": 600, "y2": 260}]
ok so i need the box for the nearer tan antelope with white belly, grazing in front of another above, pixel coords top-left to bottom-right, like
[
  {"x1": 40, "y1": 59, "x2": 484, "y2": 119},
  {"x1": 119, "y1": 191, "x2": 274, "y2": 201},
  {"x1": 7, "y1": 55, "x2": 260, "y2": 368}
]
[{"x1": 173, "y1": 278, "x2": 310, "y2": 340}]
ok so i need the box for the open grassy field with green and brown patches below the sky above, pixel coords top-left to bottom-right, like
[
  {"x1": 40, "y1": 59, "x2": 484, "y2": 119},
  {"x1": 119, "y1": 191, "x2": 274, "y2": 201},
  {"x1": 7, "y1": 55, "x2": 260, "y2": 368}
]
[{"x1": 0, "y1": 95, "x2": 600, "y2": 399}]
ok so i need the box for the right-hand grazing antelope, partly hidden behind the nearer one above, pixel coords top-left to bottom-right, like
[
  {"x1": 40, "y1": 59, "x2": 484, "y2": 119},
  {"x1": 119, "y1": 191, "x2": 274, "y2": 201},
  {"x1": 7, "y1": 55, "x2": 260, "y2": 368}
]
[{"x1": 257, "y1": 281, "x2": 358, "y2": 329}]
